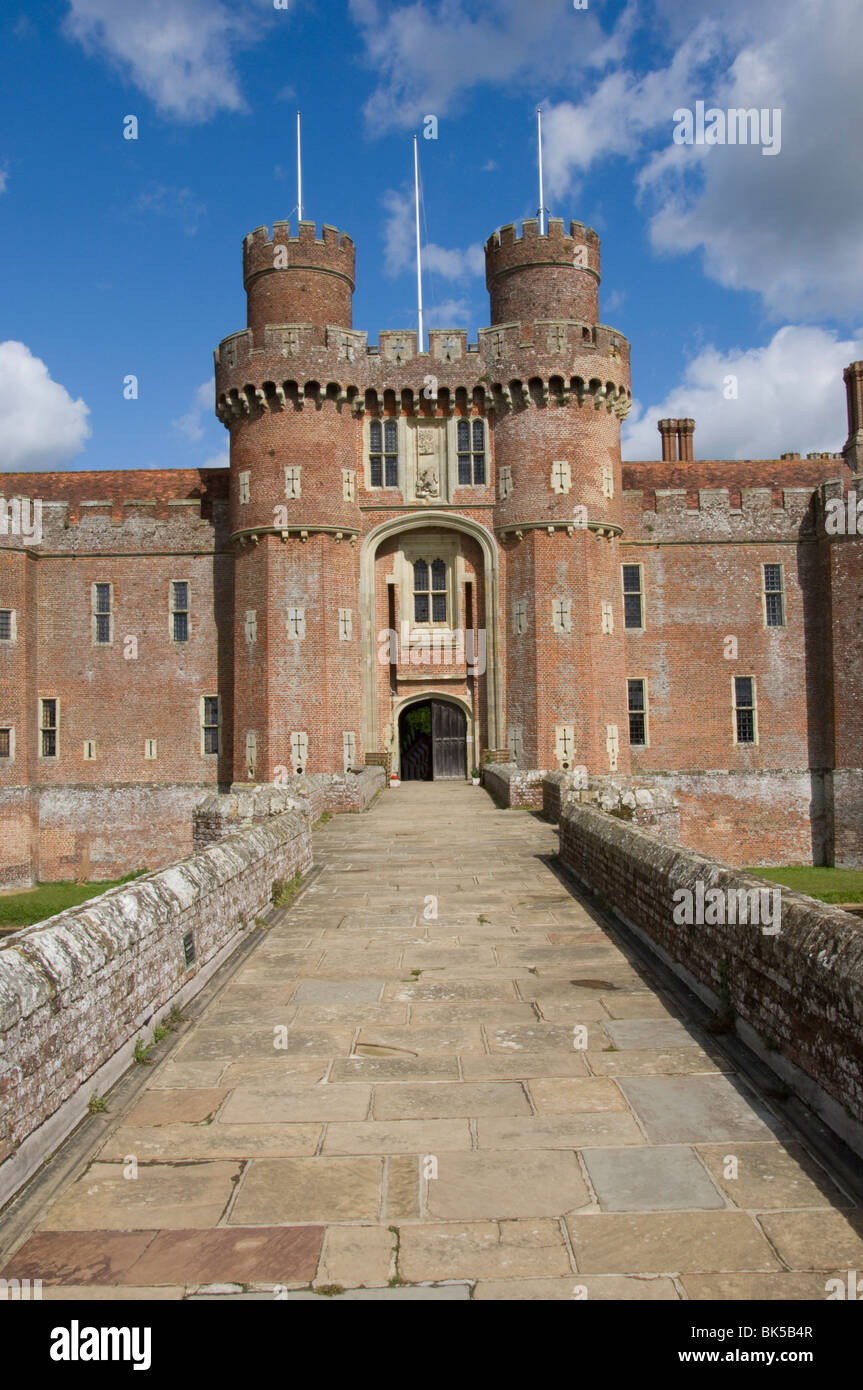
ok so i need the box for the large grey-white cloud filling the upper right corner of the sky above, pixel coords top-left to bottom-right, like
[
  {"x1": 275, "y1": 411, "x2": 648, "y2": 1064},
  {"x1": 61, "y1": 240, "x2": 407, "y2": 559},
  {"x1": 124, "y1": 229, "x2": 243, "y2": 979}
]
[{"x1": 641, "y1": 0, "x2": 863, "y2": 321}]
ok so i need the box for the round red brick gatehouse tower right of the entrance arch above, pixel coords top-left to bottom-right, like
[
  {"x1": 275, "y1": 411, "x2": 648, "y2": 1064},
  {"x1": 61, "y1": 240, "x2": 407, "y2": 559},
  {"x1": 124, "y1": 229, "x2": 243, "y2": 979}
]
[{"x1": 481, "y1": 218, "x2": 631, "y2": 776}]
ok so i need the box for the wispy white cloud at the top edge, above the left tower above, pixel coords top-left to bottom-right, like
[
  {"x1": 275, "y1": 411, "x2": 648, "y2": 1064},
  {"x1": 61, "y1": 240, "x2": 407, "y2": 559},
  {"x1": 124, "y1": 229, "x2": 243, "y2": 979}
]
[{"x1": 65, "y1": 0, "x2": 274, "y2": 121}]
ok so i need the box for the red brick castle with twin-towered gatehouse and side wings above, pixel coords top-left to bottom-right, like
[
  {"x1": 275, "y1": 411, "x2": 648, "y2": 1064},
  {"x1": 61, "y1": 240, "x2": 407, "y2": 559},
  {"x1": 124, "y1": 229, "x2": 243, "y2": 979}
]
[{"x1": 0, "y1": 218, "x2": 863, "y2": 883}]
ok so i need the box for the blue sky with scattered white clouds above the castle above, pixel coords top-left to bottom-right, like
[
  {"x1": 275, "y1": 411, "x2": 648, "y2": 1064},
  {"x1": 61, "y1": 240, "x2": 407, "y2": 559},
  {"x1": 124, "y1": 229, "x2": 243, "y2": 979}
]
[{"x1": 0, "y1": 0, "x2": 863, "y2": 468}]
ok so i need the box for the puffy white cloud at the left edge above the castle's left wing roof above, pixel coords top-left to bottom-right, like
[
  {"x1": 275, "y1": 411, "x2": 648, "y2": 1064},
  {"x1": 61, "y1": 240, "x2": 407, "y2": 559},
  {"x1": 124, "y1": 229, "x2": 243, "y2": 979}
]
[{"x1": 0, "y1": 339, "x2": 92, "y2": 473}]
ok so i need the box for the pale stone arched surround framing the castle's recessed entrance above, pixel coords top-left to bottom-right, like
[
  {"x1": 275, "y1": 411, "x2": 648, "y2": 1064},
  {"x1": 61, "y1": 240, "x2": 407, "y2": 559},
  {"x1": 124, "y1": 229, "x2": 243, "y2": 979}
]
[{"x1": 360, "y1": 507, "x2": 503, "y2": 766}]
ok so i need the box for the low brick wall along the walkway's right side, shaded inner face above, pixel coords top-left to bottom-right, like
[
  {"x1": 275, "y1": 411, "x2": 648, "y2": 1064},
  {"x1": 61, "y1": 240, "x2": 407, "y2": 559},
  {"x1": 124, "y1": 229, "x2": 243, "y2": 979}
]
[{"x1": 560, "y1": 803, "x2": 863, "y2": 1152}]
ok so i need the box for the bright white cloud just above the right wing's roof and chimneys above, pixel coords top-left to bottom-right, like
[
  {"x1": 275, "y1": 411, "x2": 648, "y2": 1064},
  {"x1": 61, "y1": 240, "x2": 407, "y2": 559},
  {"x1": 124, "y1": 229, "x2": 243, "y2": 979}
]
[{"x1": 623, "y1": 324, "x2": 863, "y2": 459}]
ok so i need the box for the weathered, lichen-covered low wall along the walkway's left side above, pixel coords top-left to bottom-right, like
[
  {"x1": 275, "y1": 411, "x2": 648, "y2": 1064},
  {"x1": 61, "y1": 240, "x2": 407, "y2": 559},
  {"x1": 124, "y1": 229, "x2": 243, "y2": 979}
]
[{"x1": 0, "y1": 812, "x2": 311, "y2": 1204}]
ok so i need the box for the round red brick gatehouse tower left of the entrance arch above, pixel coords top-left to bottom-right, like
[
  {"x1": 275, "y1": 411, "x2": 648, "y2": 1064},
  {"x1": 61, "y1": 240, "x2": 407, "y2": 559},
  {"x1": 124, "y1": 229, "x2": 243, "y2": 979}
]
[{"x1": 215, "y1": 222, "x2": 364, "y2": 783}]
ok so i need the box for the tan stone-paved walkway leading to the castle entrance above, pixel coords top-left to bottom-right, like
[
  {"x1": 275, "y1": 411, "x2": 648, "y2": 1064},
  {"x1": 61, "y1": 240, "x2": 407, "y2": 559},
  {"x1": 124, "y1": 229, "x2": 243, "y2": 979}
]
[{"x1": 6, "y1": 784, "x2": 863, "y2": 1300}]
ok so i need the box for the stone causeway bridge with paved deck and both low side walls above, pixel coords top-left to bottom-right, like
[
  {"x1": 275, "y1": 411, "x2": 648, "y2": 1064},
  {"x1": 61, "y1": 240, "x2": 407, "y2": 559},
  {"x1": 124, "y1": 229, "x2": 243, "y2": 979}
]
[{"x1": 0, "y1": 783, "x2": 863, "y2": 1301}]
